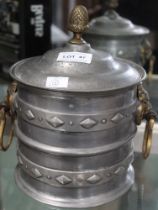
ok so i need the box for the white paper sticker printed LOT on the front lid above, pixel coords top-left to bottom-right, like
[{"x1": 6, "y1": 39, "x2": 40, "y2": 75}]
[{"x1": 57, "y1": 52, "x2": 93, "y2": 64}]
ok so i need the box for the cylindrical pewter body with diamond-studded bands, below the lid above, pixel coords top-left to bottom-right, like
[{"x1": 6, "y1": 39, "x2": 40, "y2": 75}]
[{"x1": 15, "y1": 85, "x2": 137, "y2": 207}]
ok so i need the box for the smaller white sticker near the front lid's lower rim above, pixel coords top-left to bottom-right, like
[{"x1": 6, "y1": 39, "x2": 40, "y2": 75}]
[{"x1": 46, "y1": 77, "x2": 69, "y2": 88}]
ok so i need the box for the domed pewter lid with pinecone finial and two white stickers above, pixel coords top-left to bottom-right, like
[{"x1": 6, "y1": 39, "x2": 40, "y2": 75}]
[{"x1": 10, "y1": 6, "x2": 145, "y2": 92}]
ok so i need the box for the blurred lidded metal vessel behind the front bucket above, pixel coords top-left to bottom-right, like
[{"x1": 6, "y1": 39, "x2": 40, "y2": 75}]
[{"x1": 84, "y1": 0, "x2": 154, "y2": 71}]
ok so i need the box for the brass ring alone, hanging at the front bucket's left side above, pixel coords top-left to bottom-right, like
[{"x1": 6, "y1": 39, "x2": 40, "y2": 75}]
[{"x1": 0, "y1": 109, "x2": 14, "y2": 151}]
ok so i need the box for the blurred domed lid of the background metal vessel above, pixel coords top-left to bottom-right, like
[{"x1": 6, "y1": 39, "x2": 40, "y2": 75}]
[{"x1": 87, "y1": 0, "x2": 149, "y2": 37}]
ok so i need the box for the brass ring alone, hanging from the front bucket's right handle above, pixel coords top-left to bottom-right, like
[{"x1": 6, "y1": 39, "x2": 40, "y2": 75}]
[{"x1": 142, "y1": 118, "x2": 155, "y2": 159}]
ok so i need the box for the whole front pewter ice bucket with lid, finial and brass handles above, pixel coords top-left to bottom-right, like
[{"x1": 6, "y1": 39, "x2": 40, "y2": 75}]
[{"x1": 0, "y1": 6, "x2": 155, "y2": 208}]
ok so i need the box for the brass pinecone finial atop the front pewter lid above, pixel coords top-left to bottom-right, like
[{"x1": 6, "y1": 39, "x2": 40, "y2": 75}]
[{"x1": 68, "y1": 5, "x2": 89, "y2": 44}]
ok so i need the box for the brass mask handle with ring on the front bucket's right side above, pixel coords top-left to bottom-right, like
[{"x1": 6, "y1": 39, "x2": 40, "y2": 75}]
[{"x1": 136, "y1": 84, "x2": 157, "y2": 159}]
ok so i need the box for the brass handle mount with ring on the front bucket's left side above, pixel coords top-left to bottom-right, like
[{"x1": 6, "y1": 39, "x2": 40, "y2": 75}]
[{"x1": 0, "y1": 82, "x2": 17, "y2": 151}]
